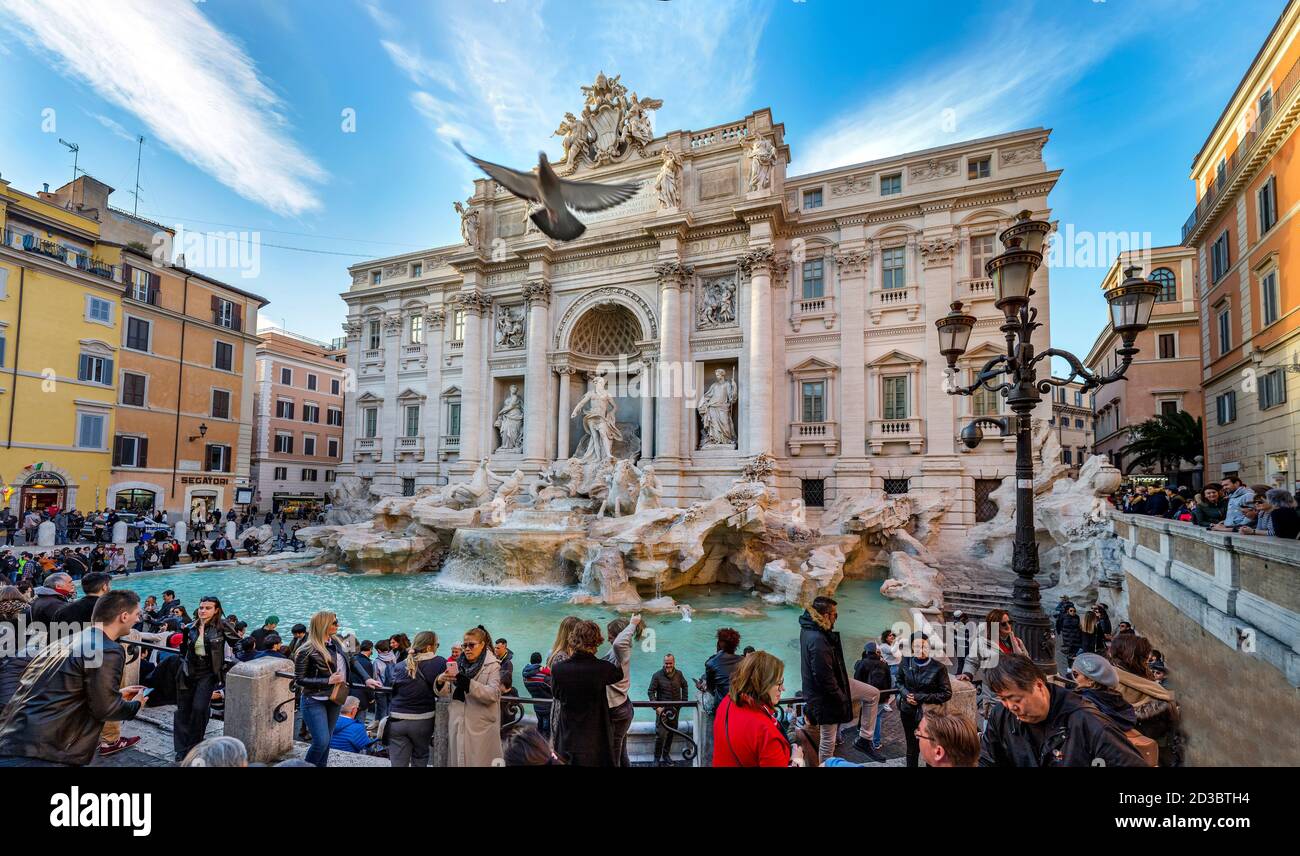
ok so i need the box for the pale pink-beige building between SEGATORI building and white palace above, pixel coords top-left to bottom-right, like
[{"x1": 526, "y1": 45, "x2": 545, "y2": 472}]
[{"x1": 252, "y1": 328, "x2": 347, "y2": 516}]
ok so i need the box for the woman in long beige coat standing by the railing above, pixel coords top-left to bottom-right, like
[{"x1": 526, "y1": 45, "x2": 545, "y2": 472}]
[{"x1": 434, "y1": 624, "x2": 502, "y2": 766}]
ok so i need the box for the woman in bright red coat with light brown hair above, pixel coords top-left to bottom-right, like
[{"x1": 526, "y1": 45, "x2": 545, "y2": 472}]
[{"x1": 714, "y1": 650, "x2": 802, "y2": 766}]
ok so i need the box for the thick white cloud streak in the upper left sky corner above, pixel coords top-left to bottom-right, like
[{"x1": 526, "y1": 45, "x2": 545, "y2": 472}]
[{"x1": 0, "y1": 0, "x2": 326, "y2": 215}]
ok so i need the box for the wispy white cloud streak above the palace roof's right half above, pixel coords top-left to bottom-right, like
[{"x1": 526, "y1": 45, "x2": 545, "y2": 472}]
[{"x1": 792, "y1": 17, "x2": 1128, "y2": 173}]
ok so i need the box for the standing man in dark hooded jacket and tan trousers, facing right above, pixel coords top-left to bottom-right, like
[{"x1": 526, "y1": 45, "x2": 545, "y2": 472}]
[{"x1": 800, "y1": 596, "x2": 885, "y2": 762}]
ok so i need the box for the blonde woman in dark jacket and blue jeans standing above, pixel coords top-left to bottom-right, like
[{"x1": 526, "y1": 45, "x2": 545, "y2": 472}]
[{"x1": 294, "y1": 610, "x2": 382, "y2": 766}]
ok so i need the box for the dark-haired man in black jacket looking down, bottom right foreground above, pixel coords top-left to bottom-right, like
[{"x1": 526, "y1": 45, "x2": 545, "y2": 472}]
[{"x1": 979, "y1": 654, "x2": 1147, "y2": 766}]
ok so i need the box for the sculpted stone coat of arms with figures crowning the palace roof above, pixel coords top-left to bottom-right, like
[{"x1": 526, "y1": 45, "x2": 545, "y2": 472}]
[{"x1": 555, "y1": 72, "x2": 663, "y2": 176}]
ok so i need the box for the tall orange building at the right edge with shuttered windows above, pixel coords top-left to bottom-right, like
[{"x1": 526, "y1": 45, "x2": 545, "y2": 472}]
[{"x1": 1183, "y1": 0, "x2": 1300, "y2": 490}]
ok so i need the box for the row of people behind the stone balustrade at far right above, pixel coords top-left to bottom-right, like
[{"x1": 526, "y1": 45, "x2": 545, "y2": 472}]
[{"x1": 1110, "y1": 476, "x2": 1300, "y2": 540}]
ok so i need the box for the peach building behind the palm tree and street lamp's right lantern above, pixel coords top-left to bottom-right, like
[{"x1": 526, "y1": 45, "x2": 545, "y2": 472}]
[{"x1": 1084, "y1": 247, "x2": 1204, "y2": 485}]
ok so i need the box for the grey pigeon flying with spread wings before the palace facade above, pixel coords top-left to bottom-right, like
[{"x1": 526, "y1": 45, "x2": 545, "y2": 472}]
[{"x1": 456, "y1": 143, "x2": 641, "y2": 241}]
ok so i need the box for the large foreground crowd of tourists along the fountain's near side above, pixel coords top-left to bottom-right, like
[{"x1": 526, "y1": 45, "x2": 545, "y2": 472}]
[{"x1": 0, "y1": 559, "x2": 1182, "y2": 766}]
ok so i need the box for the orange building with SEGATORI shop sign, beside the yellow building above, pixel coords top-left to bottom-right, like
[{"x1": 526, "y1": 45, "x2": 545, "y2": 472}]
[{"x1": 42, "y1": 176, "x2": 267, "y2": 522}]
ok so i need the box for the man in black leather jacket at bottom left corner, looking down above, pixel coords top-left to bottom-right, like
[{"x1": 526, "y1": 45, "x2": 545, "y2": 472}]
[{"x1": 0, "y1": 589, "x2": 144, "y2": 768}]
